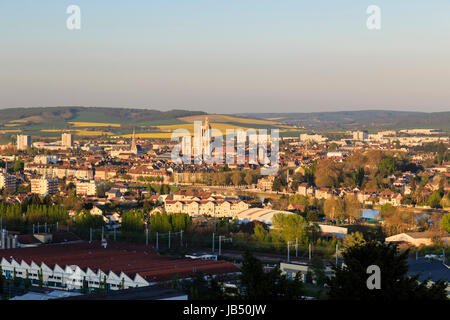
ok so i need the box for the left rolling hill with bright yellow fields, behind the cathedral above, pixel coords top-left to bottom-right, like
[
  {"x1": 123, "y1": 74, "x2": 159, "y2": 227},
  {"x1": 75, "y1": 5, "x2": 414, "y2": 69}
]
[{"x1": 0, "y1": 107, "x2": 296, "y2": 139}]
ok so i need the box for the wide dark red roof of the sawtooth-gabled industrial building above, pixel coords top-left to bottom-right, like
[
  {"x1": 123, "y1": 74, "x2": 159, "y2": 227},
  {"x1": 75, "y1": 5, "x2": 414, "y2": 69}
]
[{"x1": 0, "y1": 241, "x2": 239, "y2": 282}]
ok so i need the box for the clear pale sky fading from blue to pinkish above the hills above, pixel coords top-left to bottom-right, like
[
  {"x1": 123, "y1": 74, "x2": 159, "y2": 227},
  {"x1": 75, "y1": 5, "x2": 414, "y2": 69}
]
[{"x1": 0, "y1": 0, "x2": 450, "y2": 113}]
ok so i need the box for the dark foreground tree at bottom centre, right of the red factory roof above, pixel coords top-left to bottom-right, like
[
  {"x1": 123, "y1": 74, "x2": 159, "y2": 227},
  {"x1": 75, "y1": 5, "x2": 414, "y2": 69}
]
[{"x1": 240, "y1": 251, "x2": 303, "y2": 300}]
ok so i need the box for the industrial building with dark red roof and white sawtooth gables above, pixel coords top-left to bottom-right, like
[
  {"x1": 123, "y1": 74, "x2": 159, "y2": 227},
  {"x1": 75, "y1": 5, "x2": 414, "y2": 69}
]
[{"x1": 0, "y1": 241, "x2": 239, "y2": 291}]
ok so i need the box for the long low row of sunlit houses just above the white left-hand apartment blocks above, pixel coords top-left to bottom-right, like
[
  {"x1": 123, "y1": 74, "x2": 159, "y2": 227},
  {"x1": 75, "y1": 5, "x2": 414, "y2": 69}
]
[{"x1": 24, "y1": 163, "x2": 94, "y2": 180}]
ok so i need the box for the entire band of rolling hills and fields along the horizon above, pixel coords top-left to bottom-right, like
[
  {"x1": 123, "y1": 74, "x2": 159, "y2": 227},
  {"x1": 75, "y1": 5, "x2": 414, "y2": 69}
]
[{"x1": 0, "y1": 107, "x2": 450, "y2": 140}]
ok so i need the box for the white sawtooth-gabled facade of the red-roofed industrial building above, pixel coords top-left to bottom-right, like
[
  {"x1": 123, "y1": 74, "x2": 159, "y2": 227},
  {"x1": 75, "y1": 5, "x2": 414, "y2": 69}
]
[{"x1": 0, "y1": 258, "x2": 150, "y2": 290}]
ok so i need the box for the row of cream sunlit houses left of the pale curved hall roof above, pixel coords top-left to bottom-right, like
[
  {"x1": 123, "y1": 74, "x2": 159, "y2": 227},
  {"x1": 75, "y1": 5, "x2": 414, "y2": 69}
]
[{"x1": 164, "y1": 200, "x2": 249, "y2": 217}]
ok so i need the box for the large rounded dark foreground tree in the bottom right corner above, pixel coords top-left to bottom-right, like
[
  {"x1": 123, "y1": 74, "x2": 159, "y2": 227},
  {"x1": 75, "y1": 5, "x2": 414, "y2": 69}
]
[{"x1": 327, "y1": 242, "x2": 447, "y2": 300}]
